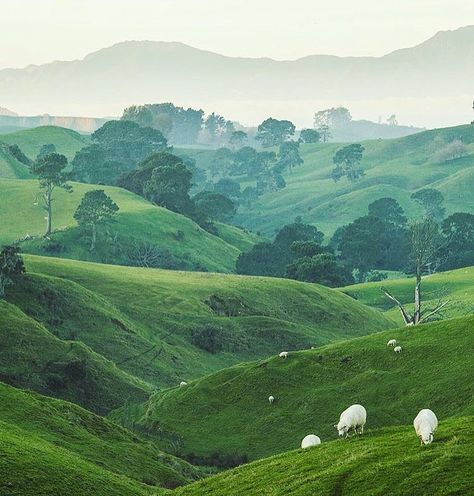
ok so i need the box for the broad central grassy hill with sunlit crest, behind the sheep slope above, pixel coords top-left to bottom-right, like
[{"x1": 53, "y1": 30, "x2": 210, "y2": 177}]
[{"x1": 8, "y1": 256, "x2": 393, "y2": 392}]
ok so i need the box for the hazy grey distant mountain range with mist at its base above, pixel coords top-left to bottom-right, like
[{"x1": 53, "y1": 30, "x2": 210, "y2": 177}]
[{"x1": 0, "y1": 26, "x2": 474, "y2": 126}]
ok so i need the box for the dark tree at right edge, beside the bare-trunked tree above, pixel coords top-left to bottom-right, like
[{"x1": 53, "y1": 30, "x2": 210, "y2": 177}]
[{"x1": 441, "y1": 212, "x2": 474, "y2": 270}]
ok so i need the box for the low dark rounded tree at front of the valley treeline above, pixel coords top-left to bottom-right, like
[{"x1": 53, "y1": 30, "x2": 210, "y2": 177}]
[{"x1": 286, "y1": 253, "x2": 354, "y2": 288}]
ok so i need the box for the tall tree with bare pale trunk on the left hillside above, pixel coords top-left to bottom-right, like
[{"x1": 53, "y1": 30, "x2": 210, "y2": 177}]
[{"x1": 31, "y1": 153, "x2": 72, "y2": 236}]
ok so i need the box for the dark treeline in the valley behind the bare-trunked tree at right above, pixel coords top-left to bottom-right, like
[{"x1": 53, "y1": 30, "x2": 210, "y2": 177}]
[{"x1": 237, "y1": 193, "x2": 474, "y2": 287}]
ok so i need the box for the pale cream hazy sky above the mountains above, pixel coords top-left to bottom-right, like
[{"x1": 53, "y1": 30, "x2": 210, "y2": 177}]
[{"x1": 0, "y1": 0, "x2": 474, "y2": 68}]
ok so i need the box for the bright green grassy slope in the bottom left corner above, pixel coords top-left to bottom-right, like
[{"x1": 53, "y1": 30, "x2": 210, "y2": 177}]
[{"x1": 0, "y1": 383, "x2": 197, "y2": 496}]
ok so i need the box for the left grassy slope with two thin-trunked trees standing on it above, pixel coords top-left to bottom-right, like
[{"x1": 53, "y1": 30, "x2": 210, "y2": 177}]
[{"x1": 0, "y1": 179, "x2": 255, "y2": 272}]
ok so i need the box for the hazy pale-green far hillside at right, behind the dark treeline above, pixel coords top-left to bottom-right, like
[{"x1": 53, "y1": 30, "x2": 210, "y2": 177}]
[{"x1": 186, "y1": 125, "x2": 474, "y2": 236}]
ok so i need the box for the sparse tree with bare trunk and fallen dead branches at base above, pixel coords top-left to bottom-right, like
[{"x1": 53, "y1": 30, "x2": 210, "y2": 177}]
[{"x1": 382, "y1": 218, "x2": 449, "y2": 326}]
